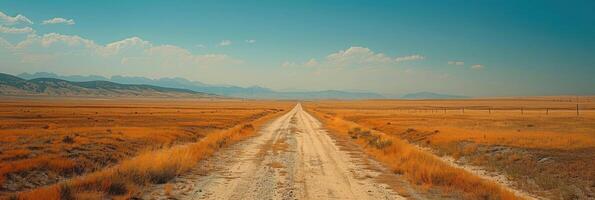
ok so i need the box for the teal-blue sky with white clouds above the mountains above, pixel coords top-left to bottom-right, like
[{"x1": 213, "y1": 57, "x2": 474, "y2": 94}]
[{"x1": 0, "y1": 0, "x2": 595, "y2": 96}]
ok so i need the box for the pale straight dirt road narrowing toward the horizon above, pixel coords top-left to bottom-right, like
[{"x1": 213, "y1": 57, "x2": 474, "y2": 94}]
[{"x1": 145, "y1": 104, "x2": 404, "y2": 199}]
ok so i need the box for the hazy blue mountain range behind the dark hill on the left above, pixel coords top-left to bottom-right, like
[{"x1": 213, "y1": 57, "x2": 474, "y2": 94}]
[{"x1": 18, "y1": 72, "x2": 384, "y2": 99}]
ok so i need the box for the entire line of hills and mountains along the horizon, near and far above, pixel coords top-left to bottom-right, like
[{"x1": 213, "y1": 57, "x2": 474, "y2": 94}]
[{"x1": 5, "y1": 72, "x2": 468, "y2": 99}]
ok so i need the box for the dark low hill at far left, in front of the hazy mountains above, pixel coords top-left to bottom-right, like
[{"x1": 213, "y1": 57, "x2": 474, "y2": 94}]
[{"x1": 0, "y1": 73, "x2": 218, "y2": 98}]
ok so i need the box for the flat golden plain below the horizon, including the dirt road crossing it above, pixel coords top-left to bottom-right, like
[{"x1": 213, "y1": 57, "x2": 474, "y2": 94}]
[{"x1": 0, "y1": 97, "x2": 595, "y2": 199}]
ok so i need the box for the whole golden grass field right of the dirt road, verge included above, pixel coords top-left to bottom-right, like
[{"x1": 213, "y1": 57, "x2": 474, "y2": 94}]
[{"x1": 304, "y1": 97, "x2": 595, "y2": 199}]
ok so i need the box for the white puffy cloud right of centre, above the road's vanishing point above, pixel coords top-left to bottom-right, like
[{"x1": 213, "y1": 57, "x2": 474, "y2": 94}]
[{"x1": 282, "y1": 46, "x2": 425, "y2": 68}]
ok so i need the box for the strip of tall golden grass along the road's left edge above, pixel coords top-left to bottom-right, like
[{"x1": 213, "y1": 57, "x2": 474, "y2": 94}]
[{"x1": 11, "y1": 108, "x2": 284, "y2": 200}]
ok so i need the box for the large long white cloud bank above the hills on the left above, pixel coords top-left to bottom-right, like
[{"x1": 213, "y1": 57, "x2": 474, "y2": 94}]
[{"x1": 5, "y1": 33, "x2": 242, "y2": 73}]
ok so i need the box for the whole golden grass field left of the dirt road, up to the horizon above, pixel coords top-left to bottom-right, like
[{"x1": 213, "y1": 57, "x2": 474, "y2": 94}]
[{"x1": 0, "y1": 98, "x2": 293, "y2": 198}]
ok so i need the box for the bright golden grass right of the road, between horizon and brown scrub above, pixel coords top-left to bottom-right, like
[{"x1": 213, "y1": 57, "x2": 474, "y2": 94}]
[{"x1": 316, "y1": 97, "x2": 595, "y2": 149}]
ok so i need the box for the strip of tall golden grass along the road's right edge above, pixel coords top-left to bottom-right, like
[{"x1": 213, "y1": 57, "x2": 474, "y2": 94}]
[{"x1": 309, "y1": 109, "x2": 520, "y2": 199}]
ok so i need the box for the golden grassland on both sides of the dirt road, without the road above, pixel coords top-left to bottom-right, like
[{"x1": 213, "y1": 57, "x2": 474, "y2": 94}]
[{"x1": 0, "y1": 97, "x2": 595, "y2": 199}]
